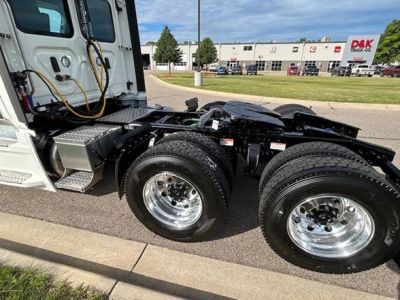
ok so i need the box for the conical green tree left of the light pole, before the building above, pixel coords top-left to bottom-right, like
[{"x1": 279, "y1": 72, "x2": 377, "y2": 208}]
[{"x1": 153, "y1": 26, "x2": 182, "y2": 75}]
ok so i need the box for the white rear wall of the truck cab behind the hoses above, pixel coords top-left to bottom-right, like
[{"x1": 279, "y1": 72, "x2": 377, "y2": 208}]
[{"x1": 0, "y1": 0, "x2": 136, "y2": 106}]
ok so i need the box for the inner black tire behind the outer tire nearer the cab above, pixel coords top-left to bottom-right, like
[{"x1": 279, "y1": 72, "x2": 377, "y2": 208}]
[{"x1": 157, "y1": 131, "x2": 234, "y2": 191}]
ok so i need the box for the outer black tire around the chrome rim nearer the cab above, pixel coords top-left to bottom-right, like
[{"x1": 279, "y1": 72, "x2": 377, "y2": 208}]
[{"x1": 125, "y1": 142, "x2": 228, "y2": 242}]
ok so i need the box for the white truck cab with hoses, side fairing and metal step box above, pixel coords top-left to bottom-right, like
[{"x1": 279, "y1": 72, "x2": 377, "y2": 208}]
[{"x1": 0, "y1": 0, "x2": 146, "y2": 191}]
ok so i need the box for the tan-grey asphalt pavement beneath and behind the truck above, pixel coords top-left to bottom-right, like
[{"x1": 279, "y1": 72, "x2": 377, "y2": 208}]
[{"x1": 0, "y1": 77, "x2": 400, "y2": 298}]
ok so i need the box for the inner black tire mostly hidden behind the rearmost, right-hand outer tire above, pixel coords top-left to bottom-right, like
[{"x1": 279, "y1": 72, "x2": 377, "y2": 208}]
[{"x1": 259, "y1": 142, "x2": 368, "y2": 195}]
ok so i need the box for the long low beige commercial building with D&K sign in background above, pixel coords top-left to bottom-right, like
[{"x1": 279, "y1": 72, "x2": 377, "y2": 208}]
[{"x1": 142, "y1": 36, "x2": 379, "y2": 72}]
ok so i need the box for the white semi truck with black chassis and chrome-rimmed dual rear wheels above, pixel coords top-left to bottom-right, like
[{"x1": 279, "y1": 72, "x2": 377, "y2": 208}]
[{"x1": 0, "y1": 0, "x2": 400, "y2": 273}]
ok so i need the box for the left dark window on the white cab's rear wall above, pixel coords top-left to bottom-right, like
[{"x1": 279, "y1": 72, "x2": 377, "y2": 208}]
[{"x1": 9, "y1": 0, "x2": 73, "y2": 37}]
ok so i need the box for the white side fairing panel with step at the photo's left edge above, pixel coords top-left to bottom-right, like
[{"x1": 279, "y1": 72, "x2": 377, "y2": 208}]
[{"x1": 0, "y1": 48, "x2": 55, "y2": 191}]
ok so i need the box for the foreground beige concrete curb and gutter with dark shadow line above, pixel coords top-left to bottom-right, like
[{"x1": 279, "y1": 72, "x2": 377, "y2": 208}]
[{"x1": 0, "y1": 213, "x2": 387, "y2": 300}]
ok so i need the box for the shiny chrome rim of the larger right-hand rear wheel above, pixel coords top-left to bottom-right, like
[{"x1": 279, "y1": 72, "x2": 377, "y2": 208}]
[{"x1": 287, "y1": 195, "x2": 375, "y2": 258}]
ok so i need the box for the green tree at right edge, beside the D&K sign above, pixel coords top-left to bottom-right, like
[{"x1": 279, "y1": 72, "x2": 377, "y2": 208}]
[{"x1": 374, "y1": 19, "x2": 400, "y2": 64}]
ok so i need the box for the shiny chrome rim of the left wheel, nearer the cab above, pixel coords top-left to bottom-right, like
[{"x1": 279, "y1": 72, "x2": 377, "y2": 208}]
[{"x1": 143, "y1": 172, "x2": 203, "y2": 230}]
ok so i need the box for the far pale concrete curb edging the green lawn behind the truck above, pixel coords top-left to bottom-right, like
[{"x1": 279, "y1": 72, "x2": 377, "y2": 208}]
[{"x1": 148, "y1": 74, "x2": 400, "y2": 111}]
